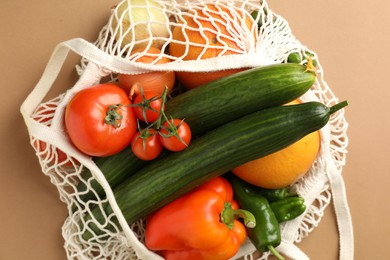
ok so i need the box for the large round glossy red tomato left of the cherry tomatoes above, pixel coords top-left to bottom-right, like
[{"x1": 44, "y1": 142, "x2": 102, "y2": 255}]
[{"x1": 65, "y1": 83, "x2": 137, "y2": 157}]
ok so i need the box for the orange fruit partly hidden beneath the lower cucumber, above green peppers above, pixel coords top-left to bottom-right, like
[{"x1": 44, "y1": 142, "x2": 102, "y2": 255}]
[{"x1": 232, "y1": 101, "x2": 321, "y2": 189}]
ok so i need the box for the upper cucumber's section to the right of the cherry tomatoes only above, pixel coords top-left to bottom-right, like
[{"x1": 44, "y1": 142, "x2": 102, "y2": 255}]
[{"x1": 165, "y1": 63, "x2": 316, "y2": 135}]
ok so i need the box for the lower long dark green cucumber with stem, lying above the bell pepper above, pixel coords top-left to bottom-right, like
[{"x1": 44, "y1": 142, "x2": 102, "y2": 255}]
[{"x1": 84, "y1": 101, "x2": 347, "y2": 238}]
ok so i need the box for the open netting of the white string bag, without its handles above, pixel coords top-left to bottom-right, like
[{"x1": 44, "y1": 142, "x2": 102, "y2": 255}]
[{"x1": 31, "y1": 0, "x2": 348, "y2": 259}]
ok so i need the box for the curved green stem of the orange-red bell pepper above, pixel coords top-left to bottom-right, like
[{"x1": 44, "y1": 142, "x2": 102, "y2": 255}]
[{"x1": 221, "y1": 202, "x2": 256, "y2": 229}]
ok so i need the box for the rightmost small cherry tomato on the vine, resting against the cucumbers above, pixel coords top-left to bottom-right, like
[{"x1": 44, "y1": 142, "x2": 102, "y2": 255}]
[{"x1": 160, "y1": 118, "x2": 191, "y2": 152}]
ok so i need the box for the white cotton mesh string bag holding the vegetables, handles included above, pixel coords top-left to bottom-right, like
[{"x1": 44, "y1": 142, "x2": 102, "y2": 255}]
[{"x1": 21, "y1": 0, "x2": 353, "y2": 259}]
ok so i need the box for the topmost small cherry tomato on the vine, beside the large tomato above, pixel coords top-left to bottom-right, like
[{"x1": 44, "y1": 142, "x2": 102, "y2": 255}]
[{"x1": 133, "y1": 91, "x2": 162, "y2": 123}]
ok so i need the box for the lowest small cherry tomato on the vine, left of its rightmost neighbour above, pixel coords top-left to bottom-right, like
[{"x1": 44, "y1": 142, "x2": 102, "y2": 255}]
[{"x1": 131, "y1": 129, "x2": 163, "y2": 161}]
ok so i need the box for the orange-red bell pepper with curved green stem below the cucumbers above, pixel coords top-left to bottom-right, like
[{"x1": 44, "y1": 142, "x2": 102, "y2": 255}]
[{"x1": 145, "y1": 177, "x2": 256, "y2": 260}]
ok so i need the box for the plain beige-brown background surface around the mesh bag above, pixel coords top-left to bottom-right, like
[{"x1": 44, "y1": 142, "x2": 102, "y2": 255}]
[{"x1": 0, "y1": 0, "x2": 390, "y2": 260}]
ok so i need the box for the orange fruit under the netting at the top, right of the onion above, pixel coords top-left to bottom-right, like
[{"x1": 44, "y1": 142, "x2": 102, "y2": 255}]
[{"x1": 169, "y1": 4, "x2": 257, "y2": 89}]
